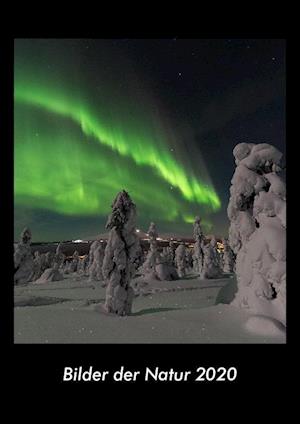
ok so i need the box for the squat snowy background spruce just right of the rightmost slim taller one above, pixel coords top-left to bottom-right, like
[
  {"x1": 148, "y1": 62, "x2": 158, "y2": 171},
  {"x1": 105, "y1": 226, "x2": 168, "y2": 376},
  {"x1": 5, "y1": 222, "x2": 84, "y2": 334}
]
[{"x1": 200, "y1": 237, "x2": 222, "y2": 278}]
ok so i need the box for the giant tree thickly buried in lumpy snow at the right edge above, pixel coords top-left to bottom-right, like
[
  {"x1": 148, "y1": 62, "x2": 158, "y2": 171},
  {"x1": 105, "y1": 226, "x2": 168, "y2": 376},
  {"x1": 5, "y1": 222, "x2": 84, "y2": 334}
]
[{"x1": 227, "y1": 143, "x2": 286, "y2": 325}]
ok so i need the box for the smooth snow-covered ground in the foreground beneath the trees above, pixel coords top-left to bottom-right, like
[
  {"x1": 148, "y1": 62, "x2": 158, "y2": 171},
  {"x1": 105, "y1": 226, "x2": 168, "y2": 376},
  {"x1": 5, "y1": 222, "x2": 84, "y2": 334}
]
[{"x1": 14, "y1": 274, "x2": 285, "y2": 343}]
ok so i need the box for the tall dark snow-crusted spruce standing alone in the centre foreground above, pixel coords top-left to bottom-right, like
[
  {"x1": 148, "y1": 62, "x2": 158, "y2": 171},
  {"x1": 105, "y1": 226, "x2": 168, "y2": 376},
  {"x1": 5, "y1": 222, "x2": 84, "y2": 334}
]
[{"x1": 102, "y1": 190, "x2": 139, "y2": 315}]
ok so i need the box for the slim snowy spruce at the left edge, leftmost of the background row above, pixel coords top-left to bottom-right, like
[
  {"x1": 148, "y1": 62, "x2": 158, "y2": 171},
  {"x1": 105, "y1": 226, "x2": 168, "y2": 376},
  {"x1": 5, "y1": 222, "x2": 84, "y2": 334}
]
[{"x1": 14, "y1": 228, "x2": 33, "y2": 284}]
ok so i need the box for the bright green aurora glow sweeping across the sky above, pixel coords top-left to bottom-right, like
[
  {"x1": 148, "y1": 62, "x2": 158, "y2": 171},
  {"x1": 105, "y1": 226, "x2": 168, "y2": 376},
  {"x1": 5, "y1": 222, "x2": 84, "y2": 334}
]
[{"x1": 14, "y1": 39, "x2": 221, "y2": 238}]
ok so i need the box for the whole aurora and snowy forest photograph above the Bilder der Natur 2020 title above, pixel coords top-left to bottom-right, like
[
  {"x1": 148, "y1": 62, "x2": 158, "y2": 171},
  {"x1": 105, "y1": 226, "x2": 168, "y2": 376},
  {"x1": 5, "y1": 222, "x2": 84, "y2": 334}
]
[{"x1": 14, "y1": 37, "x2": 286, "y2": 344}]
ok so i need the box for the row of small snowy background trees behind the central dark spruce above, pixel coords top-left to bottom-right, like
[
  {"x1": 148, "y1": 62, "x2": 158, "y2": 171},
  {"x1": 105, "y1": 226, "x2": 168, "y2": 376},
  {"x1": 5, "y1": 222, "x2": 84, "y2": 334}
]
[{"x1": 15, "y1": 212, "x2": 232, "y2": 285}]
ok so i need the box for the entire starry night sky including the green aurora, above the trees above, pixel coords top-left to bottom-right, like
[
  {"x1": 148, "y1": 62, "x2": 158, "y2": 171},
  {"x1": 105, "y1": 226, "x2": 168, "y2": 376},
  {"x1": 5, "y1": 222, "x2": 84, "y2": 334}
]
[{"x1": 14, "y1": 37, "x2": 285, "y2": 241}]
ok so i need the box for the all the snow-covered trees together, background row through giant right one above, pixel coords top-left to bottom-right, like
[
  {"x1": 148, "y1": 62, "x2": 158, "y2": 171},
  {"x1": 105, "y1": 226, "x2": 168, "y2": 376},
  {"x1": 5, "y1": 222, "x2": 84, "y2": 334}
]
[{"x1": 14, "y1": 143, "x2": 286, "y2": 325}]
